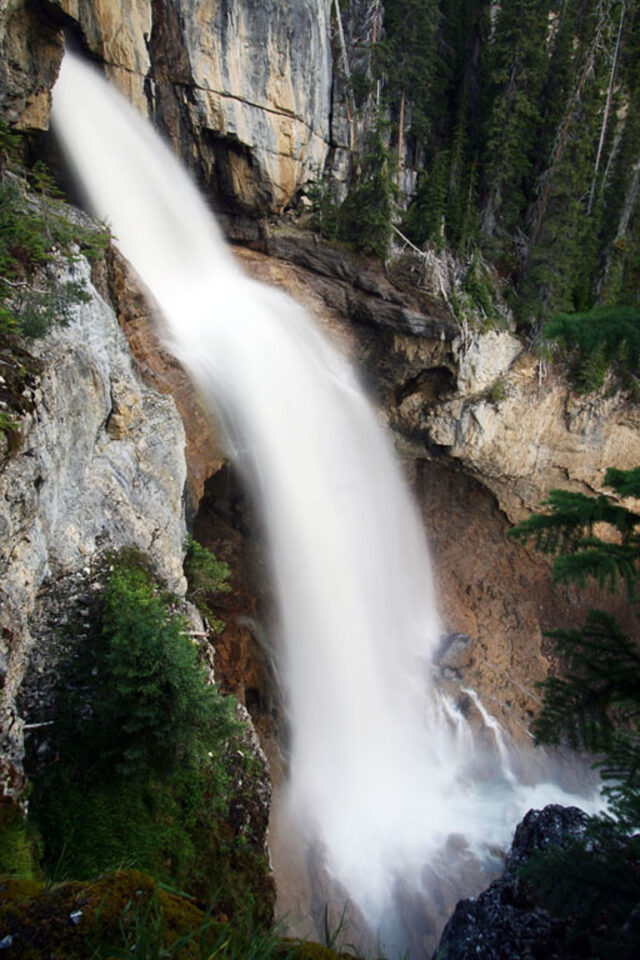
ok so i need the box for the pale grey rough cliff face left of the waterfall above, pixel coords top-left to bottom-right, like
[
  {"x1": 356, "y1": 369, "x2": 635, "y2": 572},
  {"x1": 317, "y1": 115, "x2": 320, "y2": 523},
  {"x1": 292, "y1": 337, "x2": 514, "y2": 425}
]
[{"x1": 0, "y1": 261, "x2": 186, "y2": 793}]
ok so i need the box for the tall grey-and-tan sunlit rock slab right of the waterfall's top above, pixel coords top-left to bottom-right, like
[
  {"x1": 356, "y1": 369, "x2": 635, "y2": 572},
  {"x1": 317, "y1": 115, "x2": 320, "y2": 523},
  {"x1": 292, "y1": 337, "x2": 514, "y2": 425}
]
[{"x1": 151, "y1": 0, "x2": 331, "y2": 212}]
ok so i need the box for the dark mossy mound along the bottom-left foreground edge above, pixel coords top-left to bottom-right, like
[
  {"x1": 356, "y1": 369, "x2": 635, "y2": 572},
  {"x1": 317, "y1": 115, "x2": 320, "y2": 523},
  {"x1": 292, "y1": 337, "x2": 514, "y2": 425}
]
[{"x1": 0, "y1": 870, "x2": 318, "y2": 960}]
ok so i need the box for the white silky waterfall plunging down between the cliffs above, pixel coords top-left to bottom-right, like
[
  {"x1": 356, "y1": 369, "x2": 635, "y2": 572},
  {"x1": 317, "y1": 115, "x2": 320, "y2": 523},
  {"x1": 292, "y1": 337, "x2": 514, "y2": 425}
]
[{"x1": 53, "y1": 55, "x2": 600, "y2": 956}]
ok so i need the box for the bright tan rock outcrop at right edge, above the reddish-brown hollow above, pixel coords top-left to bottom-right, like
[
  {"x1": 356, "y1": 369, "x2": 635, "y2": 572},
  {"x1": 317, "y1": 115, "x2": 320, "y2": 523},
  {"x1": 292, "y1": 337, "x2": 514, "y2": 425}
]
[{"x1": 416, "y1": 354, "x2": 640, "y2": 523}]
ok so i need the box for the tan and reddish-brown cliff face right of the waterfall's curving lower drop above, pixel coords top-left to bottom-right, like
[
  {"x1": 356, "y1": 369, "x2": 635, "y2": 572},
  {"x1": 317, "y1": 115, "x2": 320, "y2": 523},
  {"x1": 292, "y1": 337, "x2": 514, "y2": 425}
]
[{"x1": 214, "y1": 234, "x2": 640, "y2": 752}]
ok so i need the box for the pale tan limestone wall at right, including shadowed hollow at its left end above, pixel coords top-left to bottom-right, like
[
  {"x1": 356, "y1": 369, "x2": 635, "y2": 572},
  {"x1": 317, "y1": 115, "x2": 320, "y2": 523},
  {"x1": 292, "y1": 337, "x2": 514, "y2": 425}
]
[{"x1": 392, "y1": 331, "x2": 640, "y2": 523}]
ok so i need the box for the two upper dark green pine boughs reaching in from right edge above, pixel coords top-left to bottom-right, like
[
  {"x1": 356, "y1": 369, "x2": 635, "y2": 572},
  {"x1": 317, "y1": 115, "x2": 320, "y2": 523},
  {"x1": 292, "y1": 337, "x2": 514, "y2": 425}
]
[{"x1": 511, "y1": 467, "x2": 640, "y2": 830}]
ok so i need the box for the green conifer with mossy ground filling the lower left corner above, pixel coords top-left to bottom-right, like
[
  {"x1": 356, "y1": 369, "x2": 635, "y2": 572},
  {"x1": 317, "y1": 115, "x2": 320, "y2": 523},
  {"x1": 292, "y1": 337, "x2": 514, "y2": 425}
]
[{"x1": 0, "y1": 541, "x2": 283, "y2": 958}]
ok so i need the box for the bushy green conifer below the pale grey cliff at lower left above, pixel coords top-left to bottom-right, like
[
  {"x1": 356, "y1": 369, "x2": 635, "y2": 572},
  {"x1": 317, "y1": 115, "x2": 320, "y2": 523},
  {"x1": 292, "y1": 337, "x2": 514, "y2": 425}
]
[{"x1": 27, "y1": 553, "x2": 242, "y2": 896}]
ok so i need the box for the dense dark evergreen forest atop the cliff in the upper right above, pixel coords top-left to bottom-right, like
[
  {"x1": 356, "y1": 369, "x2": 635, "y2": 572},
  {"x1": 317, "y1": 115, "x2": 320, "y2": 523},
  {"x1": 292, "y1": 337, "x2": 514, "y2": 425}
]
[{"x1": 328, "y1": 0, "x2": 640, "y2": 354}]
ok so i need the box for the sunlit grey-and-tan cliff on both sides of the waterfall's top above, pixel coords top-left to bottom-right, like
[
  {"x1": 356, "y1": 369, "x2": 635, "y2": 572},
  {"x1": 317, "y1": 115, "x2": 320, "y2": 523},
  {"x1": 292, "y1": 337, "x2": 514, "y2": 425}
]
[{"x1": 0, "y1": 0, "x2": 332, "y2": 215}]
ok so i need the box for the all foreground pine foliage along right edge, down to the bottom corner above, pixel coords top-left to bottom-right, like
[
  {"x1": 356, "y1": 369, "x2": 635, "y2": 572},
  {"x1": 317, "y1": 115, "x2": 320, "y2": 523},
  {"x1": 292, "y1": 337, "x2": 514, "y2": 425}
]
[{"x1": 512, "y1": 467, "x2": 640, "y2": 960}]
